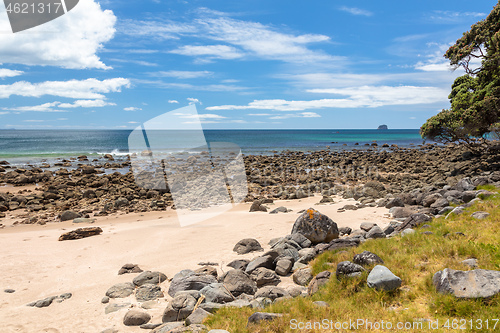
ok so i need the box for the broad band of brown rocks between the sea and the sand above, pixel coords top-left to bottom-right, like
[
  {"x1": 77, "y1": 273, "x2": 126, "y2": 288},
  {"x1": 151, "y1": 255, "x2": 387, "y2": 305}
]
[{"x1": 0, "y1": 143, "x2": 500, "y2": 224}]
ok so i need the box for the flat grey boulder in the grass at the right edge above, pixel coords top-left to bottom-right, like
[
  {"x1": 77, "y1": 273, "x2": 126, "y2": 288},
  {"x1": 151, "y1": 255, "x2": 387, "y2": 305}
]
[{"x1": 432, "y1": 268, "x2": 500, "y2": 298}]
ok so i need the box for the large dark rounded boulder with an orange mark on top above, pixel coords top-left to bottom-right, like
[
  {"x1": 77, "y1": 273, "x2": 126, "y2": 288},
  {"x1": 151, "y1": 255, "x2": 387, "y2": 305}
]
[{"x1": 291, "y1": 208, "x2": 339, "y2": 244}]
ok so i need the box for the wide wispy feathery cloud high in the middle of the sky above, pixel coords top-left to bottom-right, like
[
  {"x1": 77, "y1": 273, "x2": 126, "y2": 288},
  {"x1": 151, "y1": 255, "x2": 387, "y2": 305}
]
[{"x1": 124, "y1": 11, "x2": 336, "y2": 66}]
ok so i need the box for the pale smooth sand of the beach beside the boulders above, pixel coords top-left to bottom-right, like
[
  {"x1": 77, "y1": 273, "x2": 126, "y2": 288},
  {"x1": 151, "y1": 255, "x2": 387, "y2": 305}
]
[{"x1": 0, "y1": 197, "x2": 389, "y2": 333}]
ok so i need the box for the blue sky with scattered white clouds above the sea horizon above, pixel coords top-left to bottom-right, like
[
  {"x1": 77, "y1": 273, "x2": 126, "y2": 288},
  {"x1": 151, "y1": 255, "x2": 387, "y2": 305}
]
[{"x1": 0, "y1": 0, "x2": 496, "y2": 129}]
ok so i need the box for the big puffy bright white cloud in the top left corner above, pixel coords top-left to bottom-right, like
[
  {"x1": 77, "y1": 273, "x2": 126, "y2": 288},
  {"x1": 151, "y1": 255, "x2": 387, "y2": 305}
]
[{"x1": 0, "y1": 0, "x2": 116, "y2": 69}]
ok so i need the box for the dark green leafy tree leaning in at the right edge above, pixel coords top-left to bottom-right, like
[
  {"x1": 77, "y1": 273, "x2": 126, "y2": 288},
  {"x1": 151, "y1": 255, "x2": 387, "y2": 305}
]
[{"x1": 420, "y1": 1, "x2": 500, "y2": 145}]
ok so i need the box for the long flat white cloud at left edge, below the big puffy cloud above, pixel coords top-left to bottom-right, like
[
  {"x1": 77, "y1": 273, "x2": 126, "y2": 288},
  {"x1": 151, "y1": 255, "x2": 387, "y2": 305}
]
[{"x1": 0, "y1": 78, "x2": 130, "y2": 99}]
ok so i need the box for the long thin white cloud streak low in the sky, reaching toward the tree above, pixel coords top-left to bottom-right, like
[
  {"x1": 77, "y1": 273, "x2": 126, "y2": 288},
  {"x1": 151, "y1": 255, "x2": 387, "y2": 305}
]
[{"x1": 206, "y1": 86, "x2": 449, "y2": 111}]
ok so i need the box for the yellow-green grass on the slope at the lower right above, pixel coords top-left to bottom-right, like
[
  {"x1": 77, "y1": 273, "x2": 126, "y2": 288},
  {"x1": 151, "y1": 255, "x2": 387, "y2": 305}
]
[{"x1": 206, "y1": 191, "x2": 500, "y2": 333}]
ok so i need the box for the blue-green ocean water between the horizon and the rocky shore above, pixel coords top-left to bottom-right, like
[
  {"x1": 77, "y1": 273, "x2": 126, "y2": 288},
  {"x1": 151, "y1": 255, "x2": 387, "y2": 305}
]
[{"x1": 0, "y1": 129, "x2": 430, "y2": 164}]
